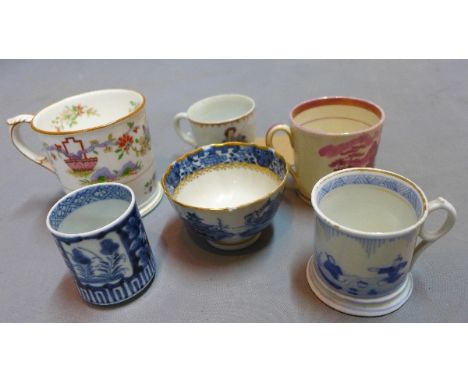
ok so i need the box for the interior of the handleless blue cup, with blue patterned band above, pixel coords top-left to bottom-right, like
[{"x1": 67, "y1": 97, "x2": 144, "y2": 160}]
[{"x1": 47, "y1": 183, "x2": 135, "y2": 236}]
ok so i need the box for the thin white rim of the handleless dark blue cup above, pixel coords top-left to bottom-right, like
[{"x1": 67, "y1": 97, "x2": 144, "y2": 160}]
[{"x1": 46, "y1": 182, "x2": 136, "y2": 239}]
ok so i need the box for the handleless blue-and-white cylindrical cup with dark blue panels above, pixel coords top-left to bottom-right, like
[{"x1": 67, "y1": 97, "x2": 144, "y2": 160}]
[{"x1": 47, "y1": 183, "x2": 156, "y2": 305}]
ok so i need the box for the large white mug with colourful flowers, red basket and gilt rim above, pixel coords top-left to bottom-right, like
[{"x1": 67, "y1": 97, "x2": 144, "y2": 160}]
[{"x1": 8, "y1": 89, "x2": 162, "y2": 215}]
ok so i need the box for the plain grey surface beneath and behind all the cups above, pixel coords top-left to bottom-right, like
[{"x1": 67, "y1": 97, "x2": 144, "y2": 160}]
[{"x1": 0, "y1": 60, "x2": 468, "y2": 322}]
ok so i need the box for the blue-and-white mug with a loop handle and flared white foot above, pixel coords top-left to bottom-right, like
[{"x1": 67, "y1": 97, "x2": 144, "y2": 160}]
[{"x1": 307, "y1": 168, "x2": 456, "y2": 316}]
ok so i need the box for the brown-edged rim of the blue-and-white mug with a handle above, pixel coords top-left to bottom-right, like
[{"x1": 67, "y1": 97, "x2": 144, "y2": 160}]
[{"x1": 310, "y1": 167, "x2": 428, "y2": 239}]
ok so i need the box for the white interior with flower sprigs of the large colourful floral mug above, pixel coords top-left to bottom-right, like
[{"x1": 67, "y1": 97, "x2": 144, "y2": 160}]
[{"x1": 33, "y1": 89, "x2": 145, "y2": 132}]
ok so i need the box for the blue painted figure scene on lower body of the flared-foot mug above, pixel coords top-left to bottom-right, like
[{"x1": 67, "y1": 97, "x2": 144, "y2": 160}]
[{"x1": 315, "y1": 250, "x2": 408, "y2": 298}]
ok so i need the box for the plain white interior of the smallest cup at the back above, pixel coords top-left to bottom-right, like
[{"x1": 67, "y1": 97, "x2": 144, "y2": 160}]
[{"x1": 187, "y1": 94, "x2": 255, "y2": 124}]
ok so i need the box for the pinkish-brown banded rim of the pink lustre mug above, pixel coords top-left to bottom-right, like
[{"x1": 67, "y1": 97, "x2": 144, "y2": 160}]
[{"x1": 289, "y1": 96, "x2": 385, "y2": 137}]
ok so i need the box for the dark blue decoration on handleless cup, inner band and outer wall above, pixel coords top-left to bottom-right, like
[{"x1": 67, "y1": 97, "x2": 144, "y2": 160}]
[{"x1": 49, "y1": 184, "x2": 156, "y2": 305}]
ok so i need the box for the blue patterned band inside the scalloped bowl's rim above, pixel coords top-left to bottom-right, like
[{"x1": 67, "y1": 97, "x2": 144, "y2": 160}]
[{"x1": 164, "y1": 143, "x2": 287, "y2": 194}]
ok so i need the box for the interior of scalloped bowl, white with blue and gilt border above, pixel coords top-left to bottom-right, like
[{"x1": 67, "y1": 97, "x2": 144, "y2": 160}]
[{"x1": 163, "y1": 143, "x2": 288, "y2": 210}]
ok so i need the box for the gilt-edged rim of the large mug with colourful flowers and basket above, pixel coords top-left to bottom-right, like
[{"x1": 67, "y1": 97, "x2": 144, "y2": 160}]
[{"x1": 31, "y1": 88, "x2": 146, "y2": 135}]
